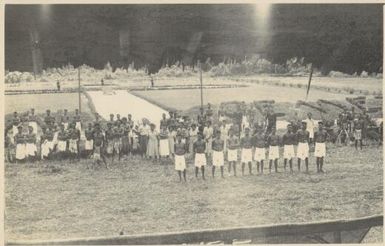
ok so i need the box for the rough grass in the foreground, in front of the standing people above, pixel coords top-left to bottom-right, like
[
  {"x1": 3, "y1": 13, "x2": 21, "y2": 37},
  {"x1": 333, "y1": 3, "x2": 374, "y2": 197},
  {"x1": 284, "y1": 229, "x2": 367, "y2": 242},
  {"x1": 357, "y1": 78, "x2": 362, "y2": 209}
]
[{"x1": 5, "y1": 146, "x2": 383, "y2": 242}]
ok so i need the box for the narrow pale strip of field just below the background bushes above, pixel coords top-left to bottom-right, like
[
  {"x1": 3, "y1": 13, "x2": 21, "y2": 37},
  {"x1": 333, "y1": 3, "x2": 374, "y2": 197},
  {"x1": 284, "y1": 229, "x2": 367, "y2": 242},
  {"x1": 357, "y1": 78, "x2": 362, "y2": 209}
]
[{"x1": 5, "y1": 74, "x2": 382, "y2": 93}]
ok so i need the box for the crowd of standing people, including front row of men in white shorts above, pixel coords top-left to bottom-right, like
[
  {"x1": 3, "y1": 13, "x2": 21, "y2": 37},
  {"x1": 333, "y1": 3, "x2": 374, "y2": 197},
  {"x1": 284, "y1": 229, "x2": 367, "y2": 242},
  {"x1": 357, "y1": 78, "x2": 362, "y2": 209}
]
[{"x1": 6, "y1": 101, "x2": 378, "y2": 180}]
